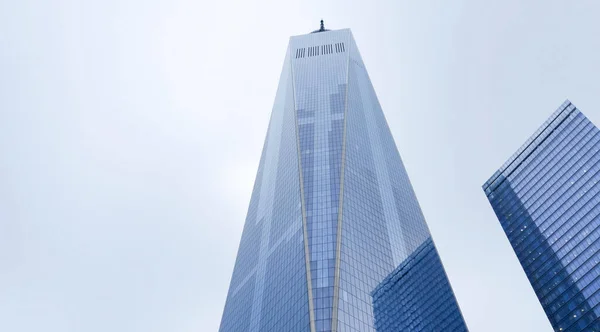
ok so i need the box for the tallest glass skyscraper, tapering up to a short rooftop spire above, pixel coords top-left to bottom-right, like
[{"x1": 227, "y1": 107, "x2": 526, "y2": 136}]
[{"x1": 220, "y1": 26, "x2": 466, "y2": 332}]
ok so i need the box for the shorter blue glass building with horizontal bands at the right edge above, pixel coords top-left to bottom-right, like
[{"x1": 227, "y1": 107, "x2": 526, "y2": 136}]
[{"x1": 483, "y1": 100, "x2": 600, "y2": 332}]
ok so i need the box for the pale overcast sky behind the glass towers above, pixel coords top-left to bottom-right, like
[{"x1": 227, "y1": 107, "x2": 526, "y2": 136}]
[{"x1": 0, "y1": 0, "x2": 600, "y2": 332}]
